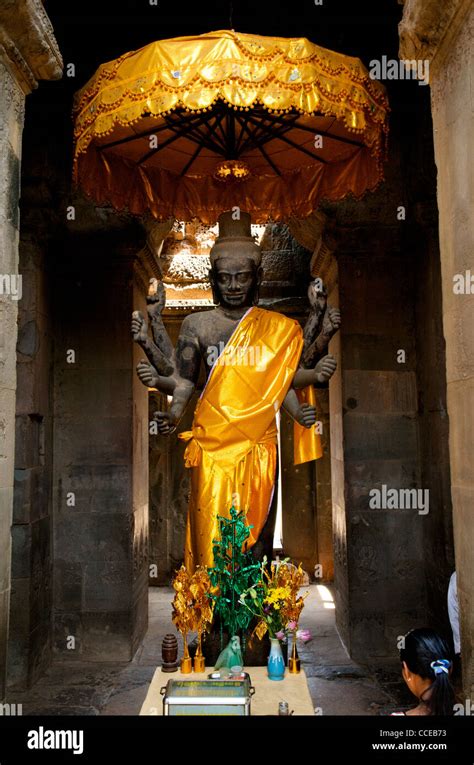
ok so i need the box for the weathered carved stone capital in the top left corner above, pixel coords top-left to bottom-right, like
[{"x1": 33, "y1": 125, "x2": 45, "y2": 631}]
[{"x1": 0, "y1": 0, "x2": 63, "y2": 94}]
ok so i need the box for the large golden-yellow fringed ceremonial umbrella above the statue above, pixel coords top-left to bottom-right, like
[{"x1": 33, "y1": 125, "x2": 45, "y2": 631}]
[{"x1": 74, "y1": 30, "x2": 388, "y2": 224}]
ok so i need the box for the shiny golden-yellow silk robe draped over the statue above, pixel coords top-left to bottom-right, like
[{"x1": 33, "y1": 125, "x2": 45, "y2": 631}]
[{"x1": 179, "y1": 307, "x2": 322, "y2": 572}]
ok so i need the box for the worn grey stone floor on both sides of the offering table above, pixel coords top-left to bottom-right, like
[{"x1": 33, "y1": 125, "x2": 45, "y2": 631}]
[{"x1": 7, "y1": 585, "x2": 412, "y2": 715}]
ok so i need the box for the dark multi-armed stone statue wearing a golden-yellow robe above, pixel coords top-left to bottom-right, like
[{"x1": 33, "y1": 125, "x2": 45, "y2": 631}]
[{"x1": 132, "y1": 212, "x2": 340, "y2": 571}]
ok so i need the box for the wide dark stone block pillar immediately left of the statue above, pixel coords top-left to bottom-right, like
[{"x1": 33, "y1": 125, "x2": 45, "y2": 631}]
[{"x1": 53, "y1": 224, "x2": 159, "y2": 661}]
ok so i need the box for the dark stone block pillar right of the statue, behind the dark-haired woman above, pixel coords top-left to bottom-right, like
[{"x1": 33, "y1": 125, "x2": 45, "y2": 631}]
[{"x1": 330, "y1": 251, "x2": 425, "y2": 661}]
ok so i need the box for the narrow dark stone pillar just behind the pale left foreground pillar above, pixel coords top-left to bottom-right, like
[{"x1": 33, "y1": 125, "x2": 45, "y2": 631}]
[{"x1": 8, "y1": 207, "x2": 56, "y2": 688}]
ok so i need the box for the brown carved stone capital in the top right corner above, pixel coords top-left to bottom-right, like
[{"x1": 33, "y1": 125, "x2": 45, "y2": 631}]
[{"x1": 398, "y1": 0, "x2": 472, "y2": 71}]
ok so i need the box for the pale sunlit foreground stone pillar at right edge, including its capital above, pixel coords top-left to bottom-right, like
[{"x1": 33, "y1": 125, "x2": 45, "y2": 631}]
[{"x1": 400, "y1": 0, "x2": 474, "y2": 698}]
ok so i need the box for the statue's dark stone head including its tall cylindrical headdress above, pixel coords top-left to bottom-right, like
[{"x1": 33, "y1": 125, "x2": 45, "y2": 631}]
[{"x1": 209, "y1": 212, "x2": 262, "y2": 308}]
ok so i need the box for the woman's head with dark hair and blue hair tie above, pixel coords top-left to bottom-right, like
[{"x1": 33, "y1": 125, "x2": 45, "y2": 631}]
[{"x1": 400, "y1": 628, "x2": 454, "y2": 715}]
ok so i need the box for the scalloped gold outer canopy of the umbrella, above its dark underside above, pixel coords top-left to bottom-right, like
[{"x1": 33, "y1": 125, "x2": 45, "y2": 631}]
[{"x1": 74, "y1": 30, "x2": 388, "y2": 166}]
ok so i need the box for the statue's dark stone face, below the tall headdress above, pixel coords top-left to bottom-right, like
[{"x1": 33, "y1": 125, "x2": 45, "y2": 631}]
[{"x1": 211, "y1": 255, "x2": 261, "y2": 308}]
